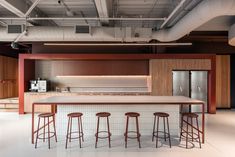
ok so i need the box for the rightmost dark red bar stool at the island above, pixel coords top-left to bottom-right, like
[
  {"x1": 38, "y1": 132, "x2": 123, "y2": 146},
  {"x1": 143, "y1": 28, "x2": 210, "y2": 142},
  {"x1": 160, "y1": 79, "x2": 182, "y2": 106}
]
[{"x1": 180, "y1": 112, "x2": 201, "y2": 149}]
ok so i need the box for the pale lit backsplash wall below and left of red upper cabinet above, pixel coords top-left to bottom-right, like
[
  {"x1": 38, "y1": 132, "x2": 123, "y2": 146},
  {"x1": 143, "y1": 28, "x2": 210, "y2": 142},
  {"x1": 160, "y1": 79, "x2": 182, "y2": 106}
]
[{"x1": 35, "y1": 61, "x2": 151, "y2": 93}]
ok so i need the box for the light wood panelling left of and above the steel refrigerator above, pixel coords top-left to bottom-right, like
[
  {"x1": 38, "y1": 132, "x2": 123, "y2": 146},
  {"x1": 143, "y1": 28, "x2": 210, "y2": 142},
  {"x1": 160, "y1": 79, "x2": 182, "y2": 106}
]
[{"x1": 150, "y1": 59, "x2": 211, "y2": 96}]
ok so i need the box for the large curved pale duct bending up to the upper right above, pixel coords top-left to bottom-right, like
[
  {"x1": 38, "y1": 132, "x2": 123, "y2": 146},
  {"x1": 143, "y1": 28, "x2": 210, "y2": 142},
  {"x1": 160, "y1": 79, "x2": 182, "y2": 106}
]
[{"x1": 152, "y1": 0, "x2": 235, "y2": 42}]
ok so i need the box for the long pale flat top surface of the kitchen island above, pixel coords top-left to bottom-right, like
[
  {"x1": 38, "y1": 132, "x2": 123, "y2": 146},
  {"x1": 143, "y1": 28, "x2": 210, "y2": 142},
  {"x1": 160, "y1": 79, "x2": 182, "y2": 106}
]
[{"x1": 34, "y1": 95, "x2": 204, "y2": 104}]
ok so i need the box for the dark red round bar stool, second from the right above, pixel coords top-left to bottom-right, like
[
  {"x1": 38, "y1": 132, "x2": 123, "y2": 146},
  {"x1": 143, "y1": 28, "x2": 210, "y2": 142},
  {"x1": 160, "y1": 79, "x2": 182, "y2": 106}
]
[{"x1": 152, "y1": 112, "x2": 171, "y2": 148}]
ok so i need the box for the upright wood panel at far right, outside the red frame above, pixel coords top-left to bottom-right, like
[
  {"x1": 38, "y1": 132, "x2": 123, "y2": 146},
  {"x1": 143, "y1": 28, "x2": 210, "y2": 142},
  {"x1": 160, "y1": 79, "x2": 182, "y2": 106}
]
[{"x1": 216, "y1": 55, "x2": 231, "y2": 108}]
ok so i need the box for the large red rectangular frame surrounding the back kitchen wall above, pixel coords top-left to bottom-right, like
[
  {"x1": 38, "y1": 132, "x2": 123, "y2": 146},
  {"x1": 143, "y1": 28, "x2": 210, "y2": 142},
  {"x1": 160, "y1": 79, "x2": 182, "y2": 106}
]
[{"x1": 19, "y1": 53, "x2": 216, "y2": 114}]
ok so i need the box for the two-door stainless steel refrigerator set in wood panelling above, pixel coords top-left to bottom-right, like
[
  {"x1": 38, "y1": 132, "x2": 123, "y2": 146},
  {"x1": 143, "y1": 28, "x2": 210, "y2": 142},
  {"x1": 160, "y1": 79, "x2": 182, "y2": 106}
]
[{"x1": 172, "y1": 71, "x2": 208, "y2": 112}]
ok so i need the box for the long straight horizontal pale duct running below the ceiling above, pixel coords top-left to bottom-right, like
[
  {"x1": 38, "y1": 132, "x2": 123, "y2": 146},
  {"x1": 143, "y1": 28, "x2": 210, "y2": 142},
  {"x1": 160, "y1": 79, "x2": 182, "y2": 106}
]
[{"x1": 0, "y1": 26, "x2": 152, "y2": 42}]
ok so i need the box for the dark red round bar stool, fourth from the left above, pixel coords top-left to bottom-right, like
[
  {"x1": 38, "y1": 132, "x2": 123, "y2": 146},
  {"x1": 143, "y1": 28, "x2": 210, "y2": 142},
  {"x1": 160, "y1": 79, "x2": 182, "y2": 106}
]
[{"x1": 124, "y1": 112, "x2": 141, "y2": 148}]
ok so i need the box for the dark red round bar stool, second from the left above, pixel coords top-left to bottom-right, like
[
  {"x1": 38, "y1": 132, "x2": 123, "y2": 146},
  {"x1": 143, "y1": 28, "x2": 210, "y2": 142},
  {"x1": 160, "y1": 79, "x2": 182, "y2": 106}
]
[{"x1": 65, "y1": 112, "x2": 84, "y2": 149}]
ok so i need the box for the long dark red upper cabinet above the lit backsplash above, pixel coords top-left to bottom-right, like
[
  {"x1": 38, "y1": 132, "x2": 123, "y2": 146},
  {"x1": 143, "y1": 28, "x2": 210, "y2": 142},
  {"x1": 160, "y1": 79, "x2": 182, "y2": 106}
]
[{"x1": 49, "y1": 60, "x2": 149, "y2": 77}]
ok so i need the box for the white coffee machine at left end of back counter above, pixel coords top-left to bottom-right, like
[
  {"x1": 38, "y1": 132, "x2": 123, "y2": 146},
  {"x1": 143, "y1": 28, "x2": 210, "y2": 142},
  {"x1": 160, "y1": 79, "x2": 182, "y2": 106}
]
[{"x1": 29, "y1": 78, "x2": 48, "y2": 92}]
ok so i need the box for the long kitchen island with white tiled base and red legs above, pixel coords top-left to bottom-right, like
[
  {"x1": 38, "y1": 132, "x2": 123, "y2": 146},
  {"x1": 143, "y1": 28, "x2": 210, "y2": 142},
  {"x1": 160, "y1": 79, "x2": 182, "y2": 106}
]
[{"x1": 32, "y1": 95, "x2": 205, "y2": 143}]
